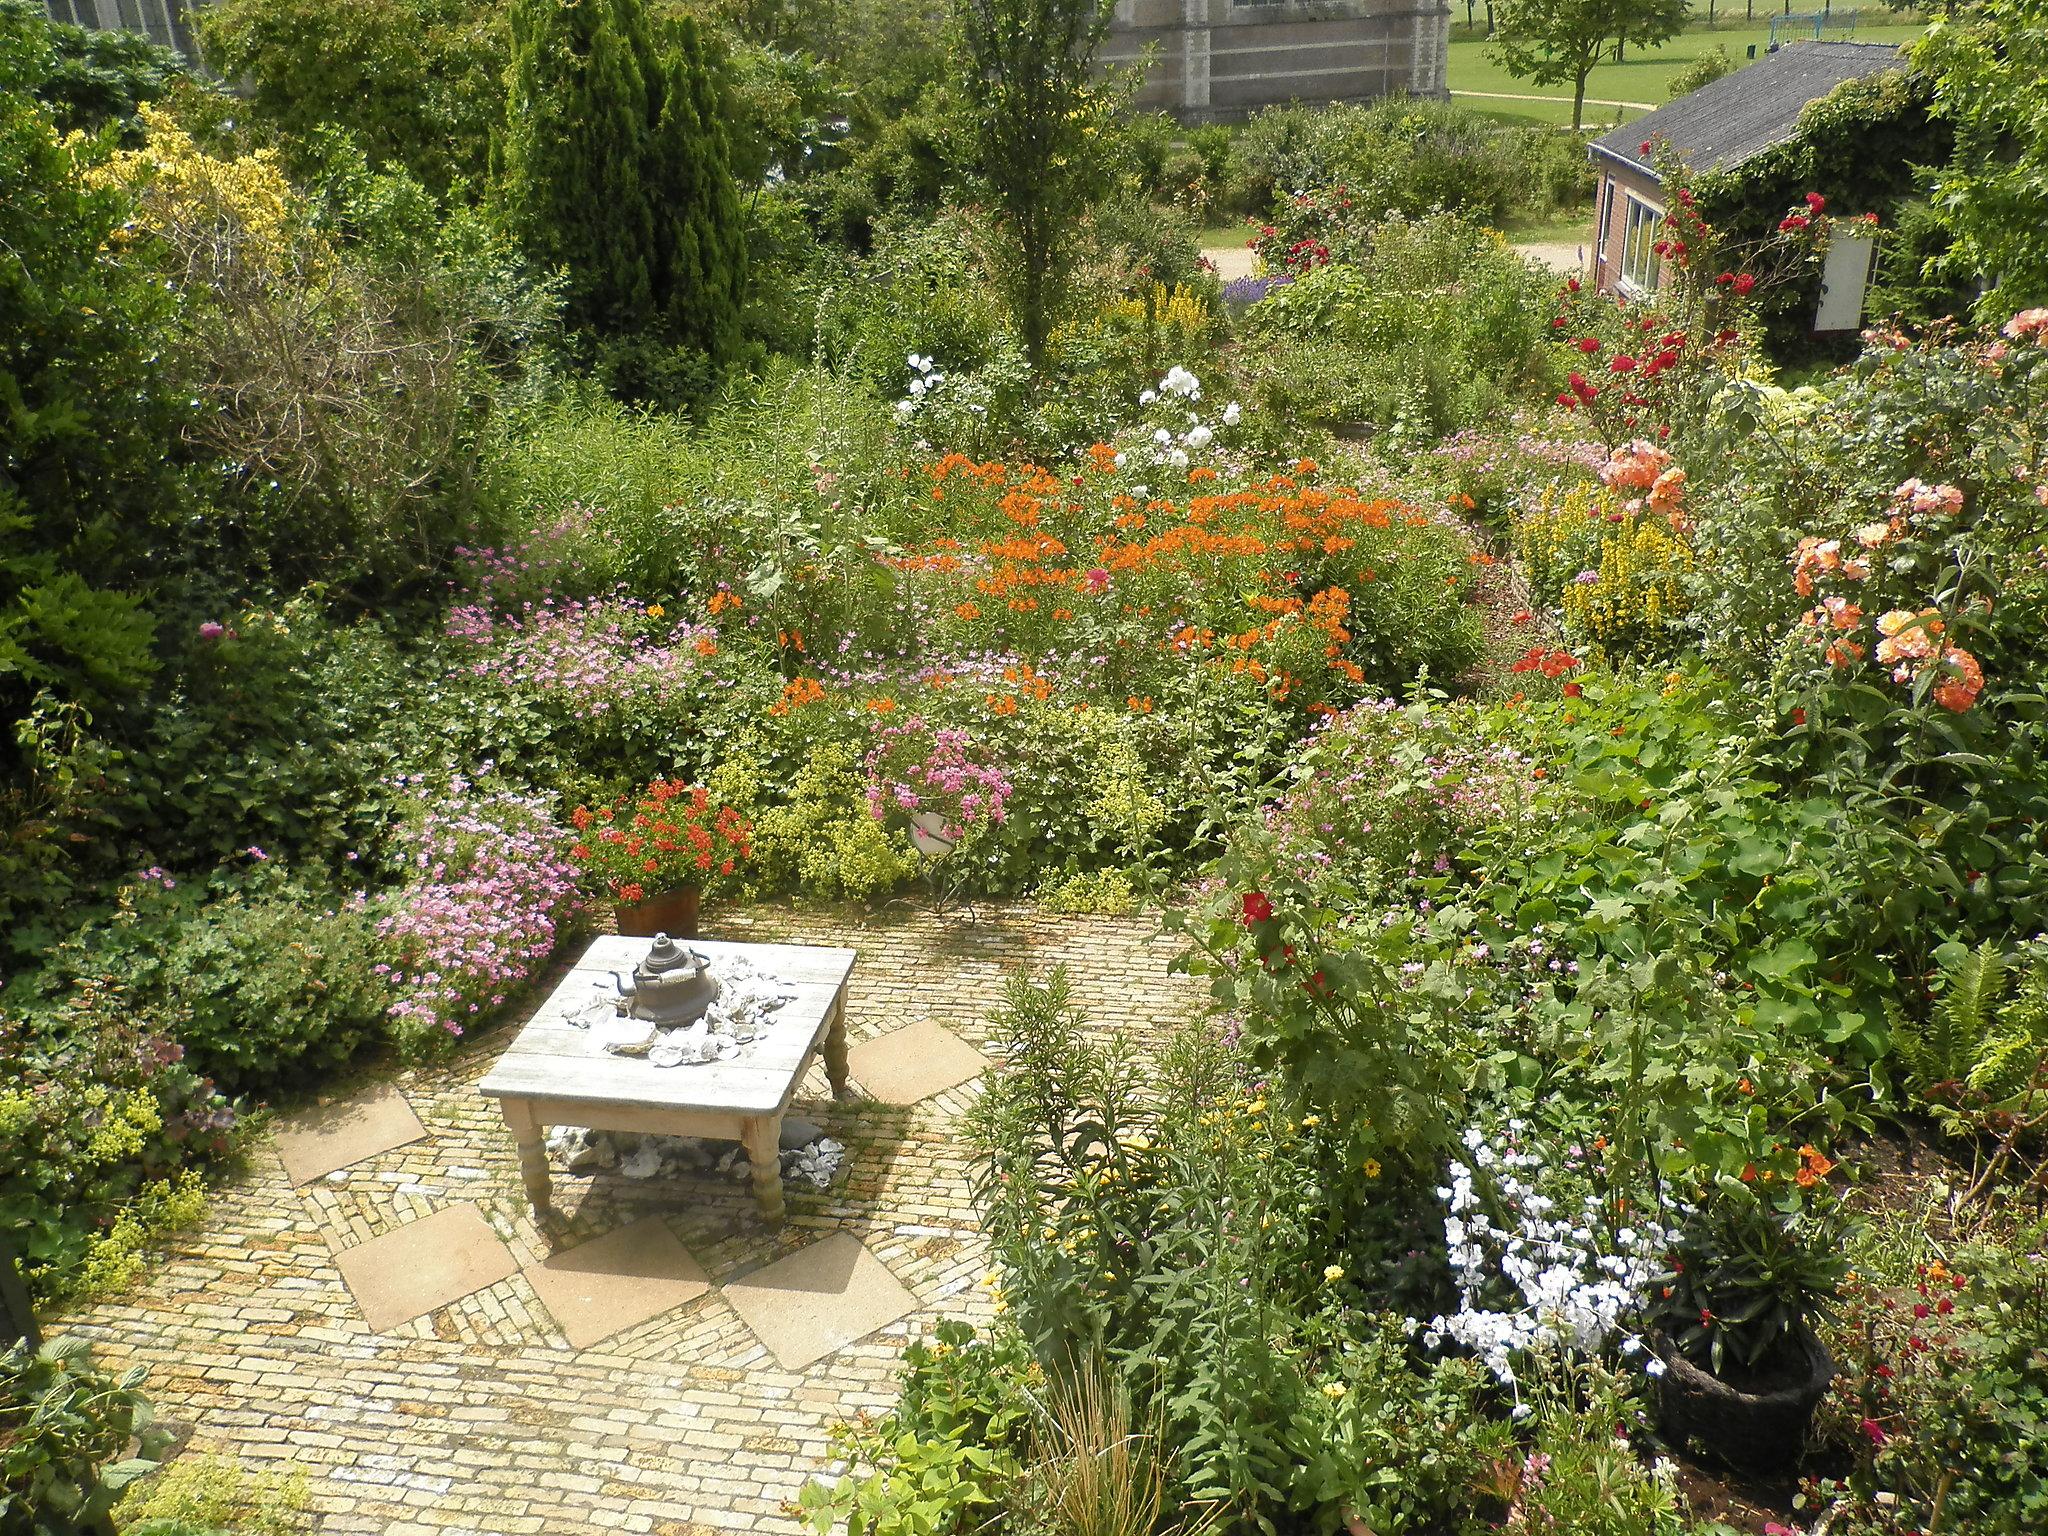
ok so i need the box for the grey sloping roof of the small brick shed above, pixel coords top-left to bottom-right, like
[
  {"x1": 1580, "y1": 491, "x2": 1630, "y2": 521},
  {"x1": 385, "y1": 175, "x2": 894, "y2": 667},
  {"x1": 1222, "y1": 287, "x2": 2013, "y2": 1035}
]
[{"x1": 1591, "y1": 43, "x2": 1901, "y2": 180}]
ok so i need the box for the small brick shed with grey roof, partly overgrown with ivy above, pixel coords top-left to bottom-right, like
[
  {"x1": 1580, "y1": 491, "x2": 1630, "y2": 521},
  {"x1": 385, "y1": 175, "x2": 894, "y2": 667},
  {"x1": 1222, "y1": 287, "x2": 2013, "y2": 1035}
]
[{"x1": 1591, "y1": 43, "x2": 1927, "y2": 332}]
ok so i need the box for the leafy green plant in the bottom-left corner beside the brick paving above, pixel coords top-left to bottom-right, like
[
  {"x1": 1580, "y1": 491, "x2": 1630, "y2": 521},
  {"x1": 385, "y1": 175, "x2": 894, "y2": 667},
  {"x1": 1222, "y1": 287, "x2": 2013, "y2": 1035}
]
[{"x1": 0, "y1": 1339, "x2": 164, "y2": 1536}]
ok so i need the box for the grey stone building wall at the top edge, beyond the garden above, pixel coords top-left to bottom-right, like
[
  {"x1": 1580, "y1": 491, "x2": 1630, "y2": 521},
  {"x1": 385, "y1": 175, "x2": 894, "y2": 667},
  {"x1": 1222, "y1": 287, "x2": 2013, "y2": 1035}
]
[{"x1": 1102, "y1": 0, "x2": 1450, "y2": 123}]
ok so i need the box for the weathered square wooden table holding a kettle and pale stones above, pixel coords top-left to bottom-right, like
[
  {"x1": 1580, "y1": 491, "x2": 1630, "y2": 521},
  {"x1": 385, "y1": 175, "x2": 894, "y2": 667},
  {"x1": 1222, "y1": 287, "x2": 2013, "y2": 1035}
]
[{"x1": 477, "y1": 936, "x2": 854, "y2": 1225}]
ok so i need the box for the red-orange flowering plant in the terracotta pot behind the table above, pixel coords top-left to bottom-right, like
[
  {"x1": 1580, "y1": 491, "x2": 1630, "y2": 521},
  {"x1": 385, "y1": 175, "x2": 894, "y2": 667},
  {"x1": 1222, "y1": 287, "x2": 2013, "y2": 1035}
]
[{"x1": 569, "y1": 778, "x2": 754, "y2": 903}]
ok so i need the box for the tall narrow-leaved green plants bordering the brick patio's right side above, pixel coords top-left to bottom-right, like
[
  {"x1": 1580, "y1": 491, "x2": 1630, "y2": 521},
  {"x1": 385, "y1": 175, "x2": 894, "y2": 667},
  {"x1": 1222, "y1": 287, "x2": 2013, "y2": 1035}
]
[{"x1": 973, "y1": 971, "x2": 1503, "y2": 1530}]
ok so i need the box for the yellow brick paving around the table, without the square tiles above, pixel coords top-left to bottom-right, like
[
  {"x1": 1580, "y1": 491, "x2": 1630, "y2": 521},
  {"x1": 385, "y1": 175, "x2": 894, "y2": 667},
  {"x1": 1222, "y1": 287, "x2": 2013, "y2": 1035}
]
[{"x1": 51, "y1": 907, "x2": 1196, "y2": 1536}]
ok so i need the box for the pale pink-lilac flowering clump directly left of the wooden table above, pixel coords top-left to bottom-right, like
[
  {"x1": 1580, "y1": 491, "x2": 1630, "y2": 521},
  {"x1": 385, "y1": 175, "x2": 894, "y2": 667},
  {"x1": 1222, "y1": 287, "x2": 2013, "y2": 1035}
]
[{"x1": 375, "y1": 778, "x2": 582, "y2": 1053}]
